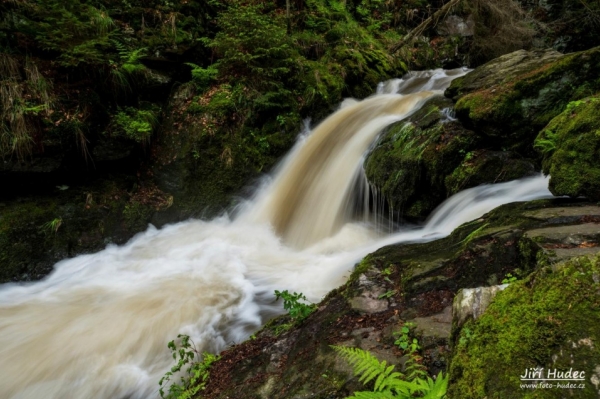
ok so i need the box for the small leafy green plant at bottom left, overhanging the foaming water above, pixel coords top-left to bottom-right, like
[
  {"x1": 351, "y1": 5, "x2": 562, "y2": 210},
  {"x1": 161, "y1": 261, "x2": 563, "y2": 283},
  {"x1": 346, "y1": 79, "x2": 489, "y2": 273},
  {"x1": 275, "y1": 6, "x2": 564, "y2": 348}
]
[{"x1": 158, "y1": 334, "x2": 219, "y2": 399}]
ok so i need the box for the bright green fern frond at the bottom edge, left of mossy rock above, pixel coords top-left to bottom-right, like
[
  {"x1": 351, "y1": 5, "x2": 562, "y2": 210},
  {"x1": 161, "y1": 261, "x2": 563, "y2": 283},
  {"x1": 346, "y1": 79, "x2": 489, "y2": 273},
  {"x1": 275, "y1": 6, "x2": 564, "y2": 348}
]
[{"x1": 332, "y1": 346, "x2": 448, "y2": 399}]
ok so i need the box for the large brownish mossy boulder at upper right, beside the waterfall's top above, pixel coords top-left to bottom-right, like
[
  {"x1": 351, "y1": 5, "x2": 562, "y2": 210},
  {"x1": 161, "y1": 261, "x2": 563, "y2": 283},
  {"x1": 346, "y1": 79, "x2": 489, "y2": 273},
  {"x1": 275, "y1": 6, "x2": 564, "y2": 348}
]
[{"x1": 446, "y1": 47, "x2": 600, "y2": 155}]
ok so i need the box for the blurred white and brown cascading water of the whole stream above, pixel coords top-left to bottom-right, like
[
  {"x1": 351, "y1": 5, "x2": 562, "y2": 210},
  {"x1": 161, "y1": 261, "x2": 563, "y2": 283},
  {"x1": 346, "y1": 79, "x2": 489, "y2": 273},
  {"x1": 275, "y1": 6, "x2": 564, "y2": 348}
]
[{"x1": 0, "y1": 70, "x2": 550, "y2": 399}]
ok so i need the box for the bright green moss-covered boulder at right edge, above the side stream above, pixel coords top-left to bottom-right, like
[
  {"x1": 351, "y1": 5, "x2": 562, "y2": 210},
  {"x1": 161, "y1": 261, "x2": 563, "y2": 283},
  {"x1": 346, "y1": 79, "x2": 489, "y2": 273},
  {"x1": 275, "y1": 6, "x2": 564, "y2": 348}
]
[{"x1": 535, "y1": 96, "x2": 600, "y2": 201}]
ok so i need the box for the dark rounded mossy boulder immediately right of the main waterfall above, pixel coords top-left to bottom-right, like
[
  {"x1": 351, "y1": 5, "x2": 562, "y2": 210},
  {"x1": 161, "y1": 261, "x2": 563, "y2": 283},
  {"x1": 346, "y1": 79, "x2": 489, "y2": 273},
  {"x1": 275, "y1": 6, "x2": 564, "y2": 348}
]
[{"x1": 365, "y1": 96, "x2": 476, "y2": 219}]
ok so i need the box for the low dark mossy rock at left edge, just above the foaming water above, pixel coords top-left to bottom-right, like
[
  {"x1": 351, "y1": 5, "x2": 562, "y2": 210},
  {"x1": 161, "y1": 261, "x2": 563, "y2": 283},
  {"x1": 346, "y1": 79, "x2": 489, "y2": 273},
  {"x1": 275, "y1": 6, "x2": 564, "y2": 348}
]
[{"x1": 0, "y1": 176, "x2": 170, "y2": 284}]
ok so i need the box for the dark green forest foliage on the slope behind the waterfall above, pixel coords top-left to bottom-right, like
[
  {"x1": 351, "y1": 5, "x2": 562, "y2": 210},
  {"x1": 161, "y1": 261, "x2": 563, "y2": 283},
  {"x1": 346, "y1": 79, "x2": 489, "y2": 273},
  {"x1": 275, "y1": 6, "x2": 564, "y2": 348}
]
[{"x1": 0, "y1": 0, "x2": 600, "y2": 169}]
